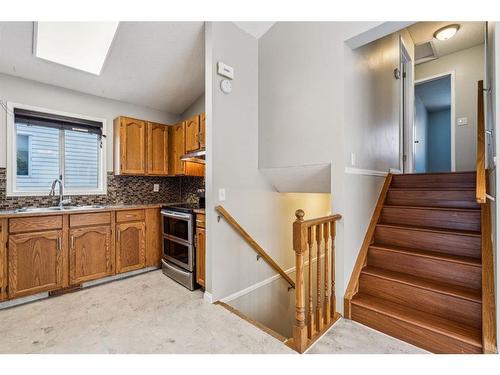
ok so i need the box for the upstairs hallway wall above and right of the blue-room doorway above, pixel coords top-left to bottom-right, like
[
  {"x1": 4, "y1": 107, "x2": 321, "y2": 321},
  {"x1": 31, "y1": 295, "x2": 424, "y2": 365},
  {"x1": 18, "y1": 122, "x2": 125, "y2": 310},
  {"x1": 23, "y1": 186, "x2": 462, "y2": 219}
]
[{"x1": 415, "y1": 44, "x2": 484, "y2": 171}]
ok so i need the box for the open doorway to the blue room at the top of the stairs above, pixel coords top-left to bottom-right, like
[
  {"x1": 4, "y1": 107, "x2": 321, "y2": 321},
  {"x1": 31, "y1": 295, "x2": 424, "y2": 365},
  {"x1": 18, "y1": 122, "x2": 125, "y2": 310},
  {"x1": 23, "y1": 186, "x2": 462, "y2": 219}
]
[{"x1": 413, "y1": 72, "x2": 455, "y2": 173}]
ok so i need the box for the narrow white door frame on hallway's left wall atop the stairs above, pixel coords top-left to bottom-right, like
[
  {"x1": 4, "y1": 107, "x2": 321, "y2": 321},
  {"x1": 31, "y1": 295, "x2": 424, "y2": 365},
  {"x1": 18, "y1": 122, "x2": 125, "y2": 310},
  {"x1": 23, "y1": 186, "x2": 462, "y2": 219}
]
[{"x1": 399, "y1": 35, "x2": 415, "y2": 173}]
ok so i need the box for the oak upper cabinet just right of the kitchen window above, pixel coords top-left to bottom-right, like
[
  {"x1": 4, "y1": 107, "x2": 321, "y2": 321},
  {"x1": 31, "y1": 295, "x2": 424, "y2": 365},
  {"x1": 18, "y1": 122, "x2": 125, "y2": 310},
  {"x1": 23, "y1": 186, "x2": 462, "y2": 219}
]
[{"x1": 114, "y1": 117, "x2": 168, "y2": 176}]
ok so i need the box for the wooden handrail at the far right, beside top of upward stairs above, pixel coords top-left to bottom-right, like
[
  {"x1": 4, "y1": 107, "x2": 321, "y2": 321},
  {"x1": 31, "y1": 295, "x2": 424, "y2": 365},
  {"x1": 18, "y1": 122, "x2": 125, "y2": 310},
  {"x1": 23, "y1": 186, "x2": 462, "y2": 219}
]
[{"x1": 476, "y1": 81, "x2": 486, "y2": 203}]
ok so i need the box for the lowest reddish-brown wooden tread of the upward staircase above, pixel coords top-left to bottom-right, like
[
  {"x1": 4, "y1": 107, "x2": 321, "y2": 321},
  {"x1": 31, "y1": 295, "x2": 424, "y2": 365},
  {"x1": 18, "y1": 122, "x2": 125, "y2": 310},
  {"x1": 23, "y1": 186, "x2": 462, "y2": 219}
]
[{"x1": 351, "y1": 293, "x2": 482, "y2": 348}]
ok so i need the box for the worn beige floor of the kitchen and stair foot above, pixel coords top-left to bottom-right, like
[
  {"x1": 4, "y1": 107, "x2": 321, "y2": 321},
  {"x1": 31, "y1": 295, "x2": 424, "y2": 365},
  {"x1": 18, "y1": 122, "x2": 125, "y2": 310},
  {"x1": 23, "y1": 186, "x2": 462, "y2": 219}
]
[{"x1": 0, "y1": 271, "x2": 422, "y2": 354}]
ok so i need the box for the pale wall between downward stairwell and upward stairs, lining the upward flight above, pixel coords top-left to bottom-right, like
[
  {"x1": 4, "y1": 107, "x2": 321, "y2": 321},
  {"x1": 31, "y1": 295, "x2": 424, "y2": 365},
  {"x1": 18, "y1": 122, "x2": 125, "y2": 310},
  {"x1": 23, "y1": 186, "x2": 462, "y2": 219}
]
[{"x1": 259, "y1": 22, "x2": 413, "y2": 310}]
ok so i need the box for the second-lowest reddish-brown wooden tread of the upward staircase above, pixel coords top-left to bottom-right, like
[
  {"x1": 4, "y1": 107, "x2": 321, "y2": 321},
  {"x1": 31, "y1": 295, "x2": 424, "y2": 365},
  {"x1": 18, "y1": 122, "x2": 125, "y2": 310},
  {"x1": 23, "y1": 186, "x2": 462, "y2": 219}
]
[{"x1": 361, "y1": 266, "x2": 482, "y2": 303}]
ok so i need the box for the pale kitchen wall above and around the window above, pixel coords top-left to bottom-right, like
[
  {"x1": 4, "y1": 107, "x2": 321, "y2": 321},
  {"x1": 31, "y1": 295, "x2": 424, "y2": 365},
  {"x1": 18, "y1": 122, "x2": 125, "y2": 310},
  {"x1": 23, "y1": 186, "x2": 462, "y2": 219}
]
[{"x1": 0, "y1": 74, "x2": 178, "y2": 171}]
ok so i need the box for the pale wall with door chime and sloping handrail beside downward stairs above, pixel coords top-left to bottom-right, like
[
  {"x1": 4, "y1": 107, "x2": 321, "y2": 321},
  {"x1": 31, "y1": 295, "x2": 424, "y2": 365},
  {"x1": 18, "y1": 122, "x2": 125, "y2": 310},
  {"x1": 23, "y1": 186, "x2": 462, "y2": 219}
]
[{"x1": 206, "y1": 22, "x2": 330, "y2": 300}]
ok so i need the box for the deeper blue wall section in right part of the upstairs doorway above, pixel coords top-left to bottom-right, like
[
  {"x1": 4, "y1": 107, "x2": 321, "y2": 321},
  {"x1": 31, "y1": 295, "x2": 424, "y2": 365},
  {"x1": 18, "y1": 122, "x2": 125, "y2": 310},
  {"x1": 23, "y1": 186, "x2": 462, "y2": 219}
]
[{"x1": 427, "y1": 109, "x2": 451, "y2": 172}]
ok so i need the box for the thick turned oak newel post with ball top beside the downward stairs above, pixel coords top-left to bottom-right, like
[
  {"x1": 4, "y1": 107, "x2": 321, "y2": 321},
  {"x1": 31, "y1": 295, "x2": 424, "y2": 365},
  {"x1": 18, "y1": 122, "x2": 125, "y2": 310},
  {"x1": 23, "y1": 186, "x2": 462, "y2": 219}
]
[{"x1": 293, "y1": 210, "x2": 307, "y2": 353}]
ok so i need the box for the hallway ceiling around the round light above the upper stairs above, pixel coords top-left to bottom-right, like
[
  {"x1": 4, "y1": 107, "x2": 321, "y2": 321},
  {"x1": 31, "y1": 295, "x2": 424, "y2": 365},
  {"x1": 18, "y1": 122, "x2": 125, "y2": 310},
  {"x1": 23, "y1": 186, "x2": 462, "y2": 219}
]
[{"x1": 408, "y1": 21, "x2": 484, "y2": 58}]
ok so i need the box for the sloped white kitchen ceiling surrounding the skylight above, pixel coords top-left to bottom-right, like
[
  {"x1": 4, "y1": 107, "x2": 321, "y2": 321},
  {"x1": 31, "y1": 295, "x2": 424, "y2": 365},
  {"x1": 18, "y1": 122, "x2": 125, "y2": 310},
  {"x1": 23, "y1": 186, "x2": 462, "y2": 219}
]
[{"x1": 0, "y1": 22, "x2": 205, "y2": 114}]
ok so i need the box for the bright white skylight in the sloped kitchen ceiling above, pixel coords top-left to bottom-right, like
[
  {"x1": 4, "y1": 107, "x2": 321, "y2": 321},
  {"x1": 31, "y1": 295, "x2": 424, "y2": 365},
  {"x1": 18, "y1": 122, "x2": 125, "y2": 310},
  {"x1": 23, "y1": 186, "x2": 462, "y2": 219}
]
[{"x1": 33, "y1": 22, "x2": 118, "y2": 75}]
